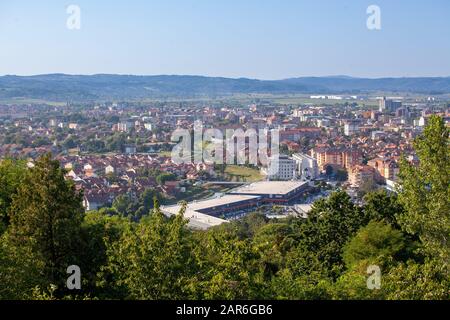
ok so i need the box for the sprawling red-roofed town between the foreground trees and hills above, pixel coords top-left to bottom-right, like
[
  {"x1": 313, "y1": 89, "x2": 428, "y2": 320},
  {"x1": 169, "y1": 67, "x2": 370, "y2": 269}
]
[{"x1": 0, "y1": 95, "x2": 450, "y2": 229}]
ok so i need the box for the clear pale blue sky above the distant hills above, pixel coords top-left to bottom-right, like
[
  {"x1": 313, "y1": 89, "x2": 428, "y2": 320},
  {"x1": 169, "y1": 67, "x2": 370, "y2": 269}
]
[{"x1": 0, "y1": 0, "x2": 450, "y2": 79}]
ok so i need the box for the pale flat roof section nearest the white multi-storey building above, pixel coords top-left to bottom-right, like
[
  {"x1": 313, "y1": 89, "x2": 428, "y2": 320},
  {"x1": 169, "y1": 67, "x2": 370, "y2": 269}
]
[{"x1": 230, "y1": 181, "x2": 308, "y2": 195}]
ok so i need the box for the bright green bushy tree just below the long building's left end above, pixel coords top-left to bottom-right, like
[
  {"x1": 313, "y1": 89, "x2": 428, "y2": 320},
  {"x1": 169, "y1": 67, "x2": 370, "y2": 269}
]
[{"x1": 104, "y1": 200, "x2": 195, "y2": 300}]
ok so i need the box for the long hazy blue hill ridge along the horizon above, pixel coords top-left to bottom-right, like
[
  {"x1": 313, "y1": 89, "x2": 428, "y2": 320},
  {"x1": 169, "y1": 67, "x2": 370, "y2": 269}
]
[{"x1": 0, "y1": 74, "x2": 450, "y2": 101}]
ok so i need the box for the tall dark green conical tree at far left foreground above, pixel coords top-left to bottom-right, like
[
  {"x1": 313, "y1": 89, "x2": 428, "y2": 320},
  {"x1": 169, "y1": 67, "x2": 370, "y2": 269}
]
[{"x1": 8, "y1": 154, "x2": 84, "y2": 285}]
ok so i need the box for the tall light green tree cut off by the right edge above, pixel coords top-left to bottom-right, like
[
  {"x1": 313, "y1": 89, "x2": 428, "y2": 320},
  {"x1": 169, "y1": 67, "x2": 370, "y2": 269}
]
[{"x1": 398, "y1": 116, "x2": 450, "y2": 265}]
